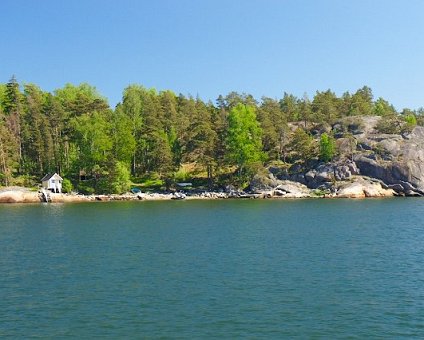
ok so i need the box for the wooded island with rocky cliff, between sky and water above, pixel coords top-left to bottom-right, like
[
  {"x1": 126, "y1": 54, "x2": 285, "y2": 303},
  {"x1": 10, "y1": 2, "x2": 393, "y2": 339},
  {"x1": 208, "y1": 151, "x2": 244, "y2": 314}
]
[{"x1": 0, "y1": 77, "x2": 424, "y2": 201}]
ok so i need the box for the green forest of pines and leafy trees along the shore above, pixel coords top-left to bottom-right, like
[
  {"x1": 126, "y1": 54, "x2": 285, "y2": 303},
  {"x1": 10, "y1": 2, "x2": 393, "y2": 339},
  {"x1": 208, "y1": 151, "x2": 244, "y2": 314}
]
[{"x1": 0, "y1": 77, "x2": 424, "y2": 194}]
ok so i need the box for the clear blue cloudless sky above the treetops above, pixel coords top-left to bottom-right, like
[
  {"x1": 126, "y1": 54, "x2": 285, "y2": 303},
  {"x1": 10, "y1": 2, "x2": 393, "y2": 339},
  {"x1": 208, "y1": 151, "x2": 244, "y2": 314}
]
[{"x1": 0, "y1": 0, "x2": 424, "y2": 109}]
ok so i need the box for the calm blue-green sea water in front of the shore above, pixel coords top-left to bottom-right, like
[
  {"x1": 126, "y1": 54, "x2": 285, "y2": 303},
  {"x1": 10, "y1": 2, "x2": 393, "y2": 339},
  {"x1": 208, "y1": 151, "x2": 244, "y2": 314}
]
[{"x1": 0, "y1": 199, "x2": 424, "y2": 339}]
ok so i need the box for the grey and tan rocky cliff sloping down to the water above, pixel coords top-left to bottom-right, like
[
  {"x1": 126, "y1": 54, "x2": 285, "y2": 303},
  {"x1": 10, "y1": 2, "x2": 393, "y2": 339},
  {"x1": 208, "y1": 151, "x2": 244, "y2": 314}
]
[{"x1": 251, "y1": 117, "x2": 424, "y2": 197}]
